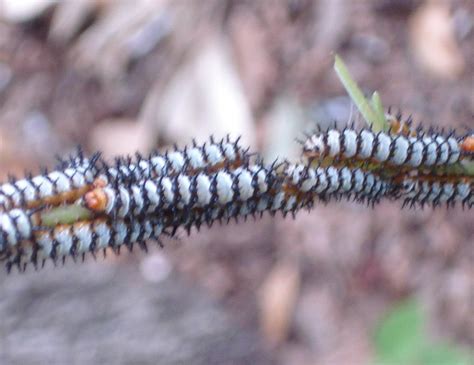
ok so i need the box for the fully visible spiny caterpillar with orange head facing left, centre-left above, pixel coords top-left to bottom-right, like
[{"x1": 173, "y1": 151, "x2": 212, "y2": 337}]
[{"x1": 84, "y1": 165, "x2": 271, "y2": 217}]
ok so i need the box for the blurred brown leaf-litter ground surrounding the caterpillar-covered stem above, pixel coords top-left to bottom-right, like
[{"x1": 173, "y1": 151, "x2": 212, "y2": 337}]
[{"x1": 0, "y1": 0, "x2": 474, "y2": 365}]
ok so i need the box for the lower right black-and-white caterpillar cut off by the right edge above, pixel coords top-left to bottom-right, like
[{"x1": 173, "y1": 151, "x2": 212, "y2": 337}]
[{"x1": 394, "y1": 175, "x2": 474, "y2": 209}]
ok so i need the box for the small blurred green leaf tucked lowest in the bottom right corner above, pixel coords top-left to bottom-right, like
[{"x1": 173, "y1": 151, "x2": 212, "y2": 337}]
[{"x1": 419, "y1": 344, "x2": 474, "y2": 365}]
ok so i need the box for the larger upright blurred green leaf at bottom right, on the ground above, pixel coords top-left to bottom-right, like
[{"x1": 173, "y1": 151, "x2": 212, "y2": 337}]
[{"x1": 374, "y1": 300, "x2": 426, "y2": 365}]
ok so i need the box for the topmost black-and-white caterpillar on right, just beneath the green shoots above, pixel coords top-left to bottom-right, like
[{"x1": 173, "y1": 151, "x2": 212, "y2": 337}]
[{"x1": 303, "y1": 128, "x2": 462, "y2": 168}]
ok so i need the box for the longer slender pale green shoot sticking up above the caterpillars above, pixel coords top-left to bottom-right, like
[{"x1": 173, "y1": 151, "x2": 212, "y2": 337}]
[{"x1": 334, "y1": 55, "x2": 387, "y2": 131}]
